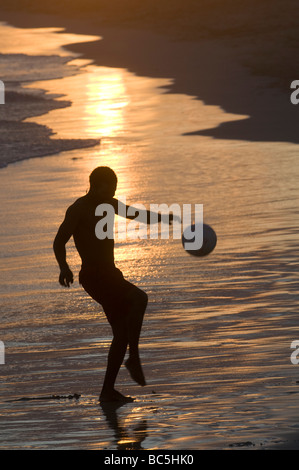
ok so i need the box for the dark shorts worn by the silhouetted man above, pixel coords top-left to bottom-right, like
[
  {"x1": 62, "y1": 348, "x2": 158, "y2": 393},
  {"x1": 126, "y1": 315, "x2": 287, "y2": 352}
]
[{"x1": 79, "y1": 267, "x2": 136, "y2": 325}]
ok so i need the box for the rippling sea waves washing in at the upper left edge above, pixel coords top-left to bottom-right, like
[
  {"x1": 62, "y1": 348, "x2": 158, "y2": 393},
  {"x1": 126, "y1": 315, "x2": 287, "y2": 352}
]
[{"x1": 0, "y1": 20, "x2": 100, "y2": 169}]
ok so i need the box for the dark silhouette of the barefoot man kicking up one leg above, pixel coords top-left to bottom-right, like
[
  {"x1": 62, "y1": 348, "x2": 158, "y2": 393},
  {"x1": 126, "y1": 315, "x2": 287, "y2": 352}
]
[{"x1": 53, "y1": 167, "x2": 172, "y2": 402}]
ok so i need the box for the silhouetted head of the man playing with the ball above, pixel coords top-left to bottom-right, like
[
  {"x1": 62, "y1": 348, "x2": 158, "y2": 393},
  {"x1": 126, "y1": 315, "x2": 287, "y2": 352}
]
[{"x1": 89, "y1": 166, "x2": 117, "y2": 198}]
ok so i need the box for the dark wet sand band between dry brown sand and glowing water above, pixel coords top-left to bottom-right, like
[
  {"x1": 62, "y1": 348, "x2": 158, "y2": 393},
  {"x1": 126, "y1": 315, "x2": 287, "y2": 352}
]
[{"x1": 0, "y1": 7, "x2": 299, "y2": 172}]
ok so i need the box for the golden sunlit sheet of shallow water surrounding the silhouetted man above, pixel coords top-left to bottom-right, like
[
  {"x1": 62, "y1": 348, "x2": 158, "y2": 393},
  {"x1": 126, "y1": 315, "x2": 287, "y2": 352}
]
[{"x1": 0, "y1": 20, "x2": 299, "y2": 449}]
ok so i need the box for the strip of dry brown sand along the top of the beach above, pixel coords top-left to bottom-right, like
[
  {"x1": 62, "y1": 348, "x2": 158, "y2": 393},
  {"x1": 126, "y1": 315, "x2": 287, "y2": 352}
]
[{"x1": 0, "y1": 0, "x2": 298, "y2": 89}]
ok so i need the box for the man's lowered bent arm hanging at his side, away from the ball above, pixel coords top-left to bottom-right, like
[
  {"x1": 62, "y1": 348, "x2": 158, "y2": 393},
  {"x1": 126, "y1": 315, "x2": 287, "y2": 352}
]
[{"x1": 53, "y1": 206, "x2": 78, "y2": 287}]
